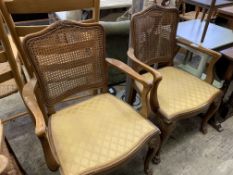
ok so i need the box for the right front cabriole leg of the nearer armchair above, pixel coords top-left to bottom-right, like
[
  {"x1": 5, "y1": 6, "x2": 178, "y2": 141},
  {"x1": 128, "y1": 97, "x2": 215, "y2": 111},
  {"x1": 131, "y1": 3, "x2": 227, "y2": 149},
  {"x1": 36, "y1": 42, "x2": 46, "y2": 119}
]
[{"x1": 144, "y1": 134, "x2": 160, "y2": 175}]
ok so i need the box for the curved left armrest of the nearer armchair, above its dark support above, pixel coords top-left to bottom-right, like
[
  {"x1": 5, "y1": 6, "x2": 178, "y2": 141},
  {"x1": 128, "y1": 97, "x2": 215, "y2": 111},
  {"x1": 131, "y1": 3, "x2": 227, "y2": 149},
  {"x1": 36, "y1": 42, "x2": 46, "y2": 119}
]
[{"x1": 22, "y1": 79, "x2": 46, "y2": 137}]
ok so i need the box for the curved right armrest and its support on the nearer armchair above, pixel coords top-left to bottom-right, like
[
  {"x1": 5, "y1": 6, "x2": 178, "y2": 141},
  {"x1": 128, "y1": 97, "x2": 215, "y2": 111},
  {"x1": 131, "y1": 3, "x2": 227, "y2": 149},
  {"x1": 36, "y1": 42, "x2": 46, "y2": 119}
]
[{"x1": 106, "y1": 58, "x2": 153, "y2": 118}]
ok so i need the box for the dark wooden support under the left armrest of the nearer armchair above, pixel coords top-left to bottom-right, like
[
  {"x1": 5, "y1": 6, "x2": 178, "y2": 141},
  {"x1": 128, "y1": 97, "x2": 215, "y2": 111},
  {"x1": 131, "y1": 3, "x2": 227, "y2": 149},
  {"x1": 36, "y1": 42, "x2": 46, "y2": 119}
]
[{"x1": 39, "y1": 135, "x2": 59, "y2": 171}]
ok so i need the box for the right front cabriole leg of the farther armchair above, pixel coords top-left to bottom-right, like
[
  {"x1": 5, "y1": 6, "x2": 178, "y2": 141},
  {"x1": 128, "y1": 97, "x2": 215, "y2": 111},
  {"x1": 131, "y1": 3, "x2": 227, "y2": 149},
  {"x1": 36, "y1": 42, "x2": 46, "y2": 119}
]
[{"x1": 201, "y1": 101, "x2": 220, "y2": 134}]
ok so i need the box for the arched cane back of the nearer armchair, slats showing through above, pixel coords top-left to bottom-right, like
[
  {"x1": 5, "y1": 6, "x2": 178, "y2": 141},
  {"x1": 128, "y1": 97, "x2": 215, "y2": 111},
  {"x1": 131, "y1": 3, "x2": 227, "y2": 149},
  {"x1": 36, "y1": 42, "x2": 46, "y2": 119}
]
[{"x1": 23, "y1": 21, "x2": 107, "y2": 108}]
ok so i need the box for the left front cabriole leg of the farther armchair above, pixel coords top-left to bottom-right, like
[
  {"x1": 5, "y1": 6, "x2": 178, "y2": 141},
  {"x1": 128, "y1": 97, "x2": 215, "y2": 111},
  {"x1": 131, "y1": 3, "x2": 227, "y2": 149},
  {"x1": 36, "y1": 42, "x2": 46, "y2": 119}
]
[{"x1": 153, "y1": 120, "x2": 176, "y2": 164}]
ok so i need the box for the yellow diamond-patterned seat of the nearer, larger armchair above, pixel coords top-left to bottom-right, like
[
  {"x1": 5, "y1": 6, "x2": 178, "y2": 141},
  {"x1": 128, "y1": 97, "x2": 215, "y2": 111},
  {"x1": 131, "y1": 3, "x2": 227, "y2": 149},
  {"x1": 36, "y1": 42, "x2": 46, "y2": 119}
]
[{"x1": 49, "y1": 94, "x2": 159, "y2": 175}]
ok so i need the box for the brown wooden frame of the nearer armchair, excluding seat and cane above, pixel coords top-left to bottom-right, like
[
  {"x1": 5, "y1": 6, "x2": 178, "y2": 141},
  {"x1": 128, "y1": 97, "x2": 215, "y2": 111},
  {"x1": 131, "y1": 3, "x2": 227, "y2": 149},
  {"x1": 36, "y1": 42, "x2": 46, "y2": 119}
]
[{"x1": 23, "y1": 21, "x2": 160, "y2": 174}]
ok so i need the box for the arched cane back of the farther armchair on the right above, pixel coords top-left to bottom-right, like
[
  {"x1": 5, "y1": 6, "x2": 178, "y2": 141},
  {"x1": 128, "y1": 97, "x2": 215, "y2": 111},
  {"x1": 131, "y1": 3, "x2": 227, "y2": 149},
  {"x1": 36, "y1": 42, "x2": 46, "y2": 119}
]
[{"x1": 131, "y1": 5, "x2": 179, "y2": 69}]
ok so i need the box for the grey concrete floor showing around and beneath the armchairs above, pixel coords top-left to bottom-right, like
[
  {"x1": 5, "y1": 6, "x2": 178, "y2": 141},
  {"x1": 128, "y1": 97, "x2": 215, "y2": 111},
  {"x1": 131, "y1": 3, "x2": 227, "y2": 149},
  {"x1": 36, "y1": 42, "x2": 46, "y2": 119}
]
[{"x1": 0, "y1": 91, "x2": 233, "y2": 175}]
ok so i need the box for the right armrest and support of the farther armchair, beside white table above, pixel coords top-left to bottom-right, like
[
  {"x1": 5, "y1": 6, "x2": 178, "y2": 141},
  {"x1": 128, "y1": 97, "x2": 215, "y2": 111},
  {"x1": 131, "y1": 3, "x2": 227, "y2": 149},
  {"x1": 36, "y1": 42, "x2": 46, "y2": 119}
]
[{"x1": 177, "y1": 38, "x2": 222, "y2": 84}]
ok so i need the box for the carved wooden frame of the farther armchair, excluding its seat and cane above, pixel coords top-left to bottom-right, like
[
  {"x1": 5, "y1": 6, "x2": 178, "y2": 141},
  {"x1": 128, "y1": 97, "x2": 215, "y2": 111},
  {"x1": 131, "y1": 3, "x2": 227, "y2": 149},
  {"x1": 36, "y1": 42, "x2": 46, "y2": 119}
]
[{"x1": 128, "y1": 5, "x2": 222, "y2": 163}]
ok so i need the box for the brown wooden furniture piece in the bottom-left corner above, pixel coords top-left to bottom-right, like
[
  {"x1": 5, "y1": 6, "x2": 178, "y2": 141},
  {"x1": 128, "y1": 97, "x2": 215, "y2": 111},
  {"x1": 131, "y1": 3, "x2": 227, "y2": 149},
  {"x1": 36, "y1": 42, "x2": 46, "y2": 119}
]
[{"x1": 0, "y1": 120, "x2": 25, "y2": 175}]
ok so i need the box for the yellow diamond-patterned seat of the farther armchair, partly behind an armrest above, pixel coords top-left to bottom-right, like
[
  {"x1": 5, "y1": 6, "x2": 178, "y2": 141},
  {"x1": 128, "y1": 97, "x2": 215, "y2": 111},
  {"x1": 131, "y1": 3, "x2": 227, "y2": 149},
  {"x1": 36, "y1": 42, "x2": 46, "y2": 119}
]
[{"x1": 135, "y1": 67, "x2": 221, "y2": 120}]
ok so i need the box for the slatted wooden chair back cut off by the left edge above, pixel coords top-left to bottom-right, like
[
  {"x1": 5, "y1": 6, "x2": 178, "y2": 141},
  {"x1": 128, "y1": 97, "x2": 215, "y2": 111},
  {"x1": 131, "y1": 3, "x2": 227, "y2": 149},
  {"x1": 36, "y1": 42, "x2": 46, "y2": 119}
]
[{"x1": 0, "y1": 13, "x2": 23, "y2": 98}]
